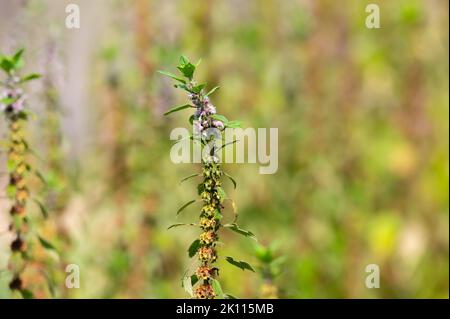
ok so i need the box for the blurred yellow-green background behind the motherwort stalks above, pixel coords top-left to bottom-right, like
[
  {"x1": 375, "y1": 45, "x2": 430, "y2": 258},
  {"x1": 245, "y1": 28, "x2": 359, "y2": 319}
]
[{"x1": 0, "y1": 0, "x2": 449, "y2": 298}]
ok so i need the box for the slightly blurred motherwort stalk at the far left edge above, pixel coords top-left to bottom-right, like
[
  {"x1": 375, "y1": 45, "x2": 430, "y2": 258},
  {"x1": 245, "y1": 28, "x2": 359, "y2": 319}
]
[{"x1": 0, "y1": 50, "x2": 52, "y2": 298}]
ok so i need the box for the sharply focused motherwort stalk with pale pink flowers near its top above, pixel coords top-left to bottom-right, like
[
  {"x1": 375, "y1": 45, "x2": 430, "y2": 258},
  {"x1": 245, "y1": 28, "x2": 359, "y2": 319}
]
[{"x1": 159, "y1": 56, "x2": 254, "y2": 299}]
